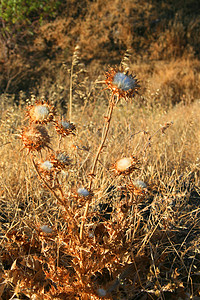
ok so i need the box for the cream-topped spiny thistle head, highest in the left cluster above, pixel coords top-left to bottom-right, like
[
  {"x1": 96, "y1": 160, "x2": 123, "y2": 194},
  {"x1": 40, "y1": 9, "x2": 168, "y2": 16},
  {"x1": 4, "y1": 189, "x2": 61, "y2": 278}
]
[{"x1": 27, "y1": 101, "x2": 55, "y2": 124}]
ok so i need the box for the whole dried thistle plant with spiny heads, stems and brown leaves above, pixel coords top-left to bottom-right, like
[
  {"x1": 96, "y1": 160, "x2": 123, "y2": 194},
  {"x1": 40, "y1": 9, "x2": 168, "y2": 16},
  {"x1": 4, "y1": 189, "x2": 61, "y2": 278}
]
[{"x1": 3, "y1": 55, "x2": 178, "y2": 300}]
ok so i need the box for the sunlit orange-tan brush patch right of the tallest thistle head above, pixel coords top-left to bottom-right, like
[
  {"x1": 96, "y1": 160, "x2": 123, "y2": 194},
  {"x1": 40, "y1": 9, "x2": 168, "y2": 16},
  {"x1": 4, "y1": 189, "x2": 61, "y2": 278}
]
[{"x1": 131, "y1": 59, "x2": 200, "y2": 107}]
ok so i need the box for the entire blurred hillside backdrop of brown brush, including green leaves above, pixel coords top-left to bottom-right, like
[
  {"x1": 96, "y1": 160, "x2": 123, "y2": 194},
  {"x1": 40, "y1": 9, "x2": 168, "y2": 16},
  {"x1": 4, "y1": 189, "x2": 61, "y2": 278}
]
[{"x1": 0, "y1": 0, "x2": 200, "y2": 106}]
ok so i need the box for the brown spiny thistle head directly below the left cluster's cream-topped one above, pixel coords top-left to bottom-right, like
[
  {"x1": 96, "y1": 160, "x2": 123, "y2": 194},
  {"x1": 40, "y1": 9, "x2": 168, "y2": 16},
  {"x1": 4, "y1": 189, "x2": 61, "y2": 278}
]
[{"x1": 21, "y1": 125, "x2": 50, "y2": 151}]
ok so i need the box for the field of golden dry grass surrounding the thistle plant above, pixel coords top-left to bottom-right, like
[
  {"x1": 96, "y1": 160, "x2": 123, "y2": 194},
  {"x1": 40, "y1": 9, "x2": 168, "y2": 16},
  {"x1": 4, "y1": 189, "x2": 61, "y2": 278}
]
[{"x1": 0, "y1": 86, "x2": 200, "y2": 299}]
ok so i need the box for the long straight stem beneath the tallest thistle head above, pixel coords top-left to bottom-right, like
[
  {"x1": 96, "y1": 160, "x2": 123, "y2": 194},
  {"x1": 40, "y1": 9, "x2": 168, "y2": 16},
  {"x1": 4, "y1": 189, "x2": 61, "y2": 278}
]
[{"x1": 80, "y1": 95, "x2": 118, "y2": 240}]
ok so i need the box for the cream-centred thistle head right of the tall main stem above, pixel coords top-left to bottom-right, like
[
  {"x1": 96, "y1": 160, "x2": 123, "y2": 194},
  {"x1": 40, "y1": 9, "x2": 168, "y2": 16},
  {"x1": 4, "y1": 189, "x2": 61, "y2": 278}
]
[{"x1": 115, "y1": 157, "x2": 137, "y2": 175}]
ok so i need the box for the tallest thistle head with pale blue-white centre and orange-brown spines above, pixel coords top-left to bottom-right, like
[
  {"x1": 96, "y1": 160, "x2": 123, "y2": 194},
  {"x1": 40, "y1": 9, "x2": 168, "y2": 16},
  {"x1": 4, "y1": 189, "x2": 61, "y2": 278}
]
[{"x1": 105, "y1": 68, "x2": 139, "y2": 101}]
